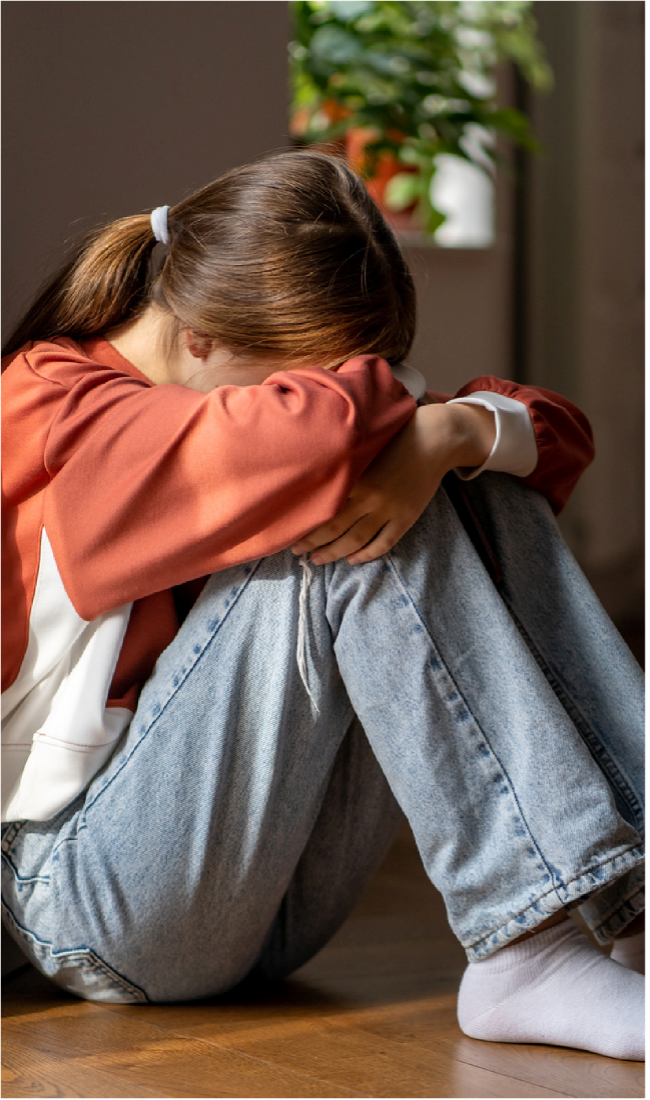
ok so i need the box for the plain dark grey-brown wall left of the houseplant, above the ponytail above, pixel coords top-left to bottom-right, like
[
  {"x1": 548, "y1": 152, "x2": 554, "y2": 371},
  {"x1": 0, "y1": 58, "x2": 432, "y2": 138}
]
[{"x1": 0, "y1": 0, "x2": 288, "y2": 336}]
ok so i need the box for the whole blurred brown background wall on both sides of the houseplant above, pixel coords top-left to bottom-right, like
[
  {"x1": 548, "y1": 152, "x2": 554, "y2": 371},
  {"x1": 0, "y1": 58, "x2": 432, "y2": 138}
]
[{"x1": 0, "y1": 0, "x2": 645, "y2": 638}]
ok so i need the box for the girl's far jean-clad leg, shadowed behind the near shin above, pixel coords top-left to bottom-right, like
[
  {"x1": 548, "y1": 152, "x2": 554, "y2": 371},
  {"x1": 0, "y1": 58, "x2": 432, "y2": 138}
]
[{"x1": 466, "y1": 475, "x2": 646, "y2": 944}]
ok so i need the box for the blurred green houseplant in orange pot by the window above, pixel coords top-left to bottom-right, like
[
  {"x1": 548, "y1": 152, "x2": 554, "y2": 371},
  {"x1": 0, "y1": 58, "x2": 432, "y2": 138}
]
[{"x1": 289, "y1": 0, "x2": 551, "y2": 234}]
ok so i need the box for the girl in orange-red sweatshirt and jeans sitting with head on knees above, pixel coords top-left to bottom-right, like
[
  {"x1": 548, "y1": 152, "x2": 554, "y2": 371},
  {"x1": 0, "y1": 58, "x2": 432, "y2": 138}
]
[{"x1": 0, "y1": 152, "x2": 645, "y2": 1058}]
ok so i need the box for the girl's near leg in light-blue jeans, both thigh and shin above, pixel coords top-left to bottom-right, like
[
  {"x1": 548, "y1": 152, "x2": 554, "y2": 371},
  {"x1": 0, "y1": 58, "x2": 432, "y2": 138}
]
[{"x1": 3, "y1": 481, "x2": 642, "y2": 1020}]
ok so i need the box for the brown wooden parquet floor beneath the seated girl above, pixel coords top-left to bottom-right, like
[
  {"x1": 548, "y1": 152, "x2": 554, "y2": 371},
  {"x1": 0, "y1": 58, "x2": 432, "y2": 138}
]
[{"x1": 0, "y1": 831, "x2": 646, "y2": 1100}]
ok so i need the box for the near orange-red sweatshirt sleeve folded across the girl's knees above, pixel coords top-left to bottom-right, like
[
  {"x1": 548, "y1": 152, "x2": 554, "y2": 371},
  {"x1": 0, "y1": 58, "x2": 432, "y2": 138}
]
[{"x1": 35, "y1": 356, "x2": 416, "y2": 619}]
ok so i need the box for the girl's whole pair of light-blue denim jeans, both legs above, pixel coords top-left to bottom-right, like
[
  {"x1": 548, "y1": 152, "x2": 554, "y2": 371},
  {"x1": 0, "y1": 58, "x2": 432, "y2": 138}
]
[{"x1": 0, "y1": 474, "x2": 645, "y2": 1001}]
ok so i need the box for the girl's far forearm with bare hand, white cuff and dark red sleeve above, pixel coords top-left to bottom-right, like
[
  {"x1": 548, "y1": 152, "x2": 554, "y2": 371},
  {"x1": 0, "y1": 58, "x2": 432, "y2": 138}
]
[{"x1": 293, "y1": 376, "x2": 594, "y2": 564}]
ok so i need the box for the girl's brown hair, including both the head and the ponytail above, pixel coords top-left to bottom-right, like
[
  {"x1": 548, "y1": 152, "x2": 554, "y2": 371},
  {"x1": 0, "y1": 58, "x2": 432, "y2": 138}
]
[{"x1": 2, "y1": 151, "x2": 416, "y2": 366}]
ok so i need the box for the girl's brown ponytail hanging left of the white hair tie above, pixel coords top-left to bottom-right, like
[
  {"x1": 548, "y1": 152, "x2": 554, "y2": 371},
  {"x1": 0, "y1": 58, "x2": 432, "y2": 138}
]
[{"x1": 0, "y1": 215, "x2": 156, "y2": 356}]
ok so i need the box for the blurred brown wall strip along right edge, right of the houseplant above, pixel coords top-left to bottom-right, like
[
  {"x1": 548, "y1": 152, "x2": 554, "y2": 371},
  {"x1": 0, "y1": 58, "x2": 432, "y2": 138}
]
[{"x1": 527, "y1": 0, "x2": 646, "y2": 639}]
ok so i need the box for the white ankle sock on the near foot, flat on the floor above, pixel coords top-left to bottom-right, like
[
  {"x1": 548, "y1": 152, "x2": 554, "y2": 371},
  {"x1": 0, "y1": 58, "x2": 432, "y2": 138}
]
[{"x1": 459, "y1": 921, "x2": 646, "y2": 1062}]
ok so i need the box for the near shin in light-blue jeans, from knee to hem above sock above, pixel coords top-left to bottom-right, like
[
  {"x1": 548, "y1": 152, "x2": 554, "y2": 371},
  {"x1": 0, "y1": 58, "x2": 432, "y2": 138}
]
[{"x1": 328, "y1": 480, "x2": 645, "y2": 959}]
